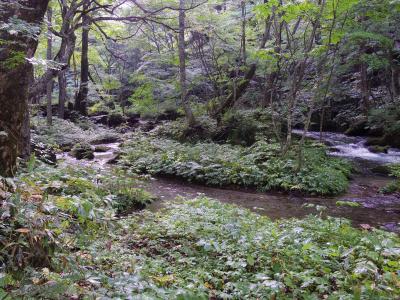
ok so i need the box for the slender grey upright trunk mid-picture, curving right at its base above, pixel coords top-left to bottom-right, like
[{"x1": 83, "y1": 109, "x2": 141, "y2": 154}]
[{"x1": 178, "y1": 0, "x2": 196, "y2": 127}]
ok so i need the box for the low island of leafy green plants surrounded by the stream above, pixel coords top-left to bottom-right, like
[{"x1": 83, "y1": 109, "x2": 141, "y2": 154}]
[{"x1": 121, "y1": 135, "x2": 351, "y2": 195}]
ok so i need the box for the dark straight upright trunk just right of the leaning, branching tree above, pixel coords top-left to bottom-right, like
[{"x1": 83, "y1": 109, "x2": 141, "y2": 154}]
[{"x1": 75, "y1": 0, "x2": 90, "y2": 115}]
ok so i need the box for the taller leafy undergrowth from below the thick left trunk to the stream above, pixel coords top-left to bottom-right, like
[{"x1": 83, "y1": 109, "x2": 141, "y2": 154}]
[{"x1": 0, "y1": 159, "x2": 153, "y2": 299}]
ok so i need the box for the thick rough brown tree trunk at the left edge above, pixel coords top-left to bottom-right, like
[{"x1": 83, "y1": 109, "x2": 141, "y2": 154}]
[{"x1": 0, "y1": 0, "x2": 48, "y2": 176}]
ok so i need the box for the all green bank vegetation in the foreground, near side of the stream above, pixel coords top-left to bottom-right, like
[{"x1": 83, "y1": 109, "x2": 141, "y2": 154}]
[{"x1": 0, "y1": 175, "x2": 400, "y2": 299}]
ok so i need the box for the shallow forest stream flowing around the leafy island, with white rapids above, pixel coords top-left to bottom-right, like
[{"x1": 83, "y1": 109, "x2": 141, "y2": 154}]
[{"x1": 58, "y1": 131, "x2": 400, "y2": 233}]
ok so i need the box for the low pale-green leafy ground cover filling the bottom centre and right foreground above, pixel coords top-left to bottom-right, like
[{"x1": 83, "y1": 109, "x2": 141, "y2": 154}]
[{"x1": 7, "y1": 198, "x2": 400, "y2": 299}]
